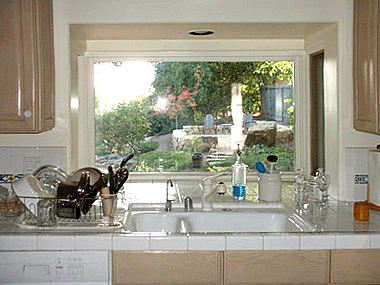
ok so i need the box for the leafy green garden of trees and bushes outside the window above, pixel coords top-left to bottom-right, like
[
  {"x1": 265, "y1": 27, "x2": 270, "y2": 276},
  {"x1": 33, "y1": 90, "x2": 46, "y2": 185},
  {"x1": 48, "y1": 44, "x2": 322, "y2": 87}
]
[{"x1": 95, "y1": 61, "x2": 294, "y2": 172}]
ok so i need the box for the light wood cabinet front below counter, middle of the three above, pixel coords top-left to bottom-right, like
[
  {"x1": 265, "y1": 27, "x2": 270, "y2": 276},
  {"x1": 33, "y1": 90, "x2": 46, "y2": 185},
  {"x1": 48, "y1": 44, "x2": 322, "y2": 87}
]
[{"x1": 225, "y1": 251, "x2": 330, "y2": 285}]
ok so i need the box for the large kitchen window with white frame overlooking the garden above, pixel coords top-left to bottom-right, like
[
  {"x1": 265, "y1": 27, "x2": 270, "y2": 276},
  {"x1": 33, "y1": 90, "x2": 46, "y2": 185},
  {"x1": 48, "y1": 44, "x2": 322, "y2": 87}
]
[{"x1": 78, "y1": 50, "x2": 307, "y2": 176}]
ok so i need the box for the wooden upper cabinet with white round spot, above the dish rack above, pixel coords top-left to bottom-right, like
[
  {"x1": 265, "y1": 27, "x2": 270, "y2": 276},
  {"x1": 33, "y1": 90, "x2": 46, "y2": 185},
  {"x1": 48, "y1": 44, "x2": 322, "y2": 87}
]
[{"x1": 0, "y1": 0, "x2": 55, "y2": 133}]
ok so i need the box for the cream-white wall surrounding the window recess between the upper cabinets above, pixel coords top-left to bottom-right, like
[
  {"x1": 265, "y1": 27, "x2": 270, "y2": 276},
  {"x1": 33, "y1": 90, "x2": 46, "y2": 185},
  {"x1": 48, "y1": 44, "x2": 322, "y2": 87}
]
[{"x1": 0, "y1": 0, "x2": 379, "y2": 198}]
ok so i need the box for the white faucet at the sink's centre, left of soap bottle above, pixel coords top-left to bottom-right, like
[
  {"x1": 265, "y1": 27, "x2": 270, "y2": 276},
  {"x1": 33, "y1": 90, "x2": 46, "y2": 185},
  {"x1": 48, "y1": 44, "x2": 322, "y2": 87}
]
[{"x1": 200, "y1": 172, "x2": 227, "y2": 211}]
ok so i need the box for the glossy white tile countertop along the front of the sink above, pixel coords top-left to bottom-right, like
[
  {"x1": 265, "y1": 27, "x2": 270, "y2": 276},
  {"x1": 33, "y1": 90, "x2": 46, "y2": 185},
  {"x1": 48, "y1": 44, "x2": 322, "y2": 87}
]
[{"x1": 0, "y1": 181, "x2": 380, "y2": 251}]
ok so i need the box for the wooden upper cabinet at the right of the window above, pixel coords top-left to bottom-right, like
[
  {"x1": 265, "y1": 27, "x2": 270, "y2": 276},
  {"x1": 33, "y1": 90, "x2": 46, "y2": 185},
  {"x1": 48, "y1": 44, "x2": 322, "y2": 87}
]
[{"x1": 353, "y1": 0, "x2": 380, "y2": 134}]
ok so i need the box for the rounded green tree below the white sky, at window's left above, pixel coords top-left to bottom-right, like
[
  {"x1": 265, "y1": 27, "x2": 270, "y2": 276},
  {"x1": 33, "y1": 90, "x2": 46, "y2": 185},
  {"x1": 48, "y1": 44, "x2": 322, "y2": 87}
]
[{"x1": 95, "y1": 98, "x2": 150, "y2": 153}]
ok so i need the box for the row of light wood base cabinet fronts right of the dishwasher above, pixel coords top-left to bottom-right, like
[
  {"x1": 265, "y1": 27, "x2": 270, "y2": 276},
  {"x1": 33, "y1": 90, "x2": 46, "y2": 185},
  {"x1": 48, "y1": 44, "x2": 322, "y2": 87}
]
[{"x1": 113, "y1": 249, "x2": 380, "y2": 285}]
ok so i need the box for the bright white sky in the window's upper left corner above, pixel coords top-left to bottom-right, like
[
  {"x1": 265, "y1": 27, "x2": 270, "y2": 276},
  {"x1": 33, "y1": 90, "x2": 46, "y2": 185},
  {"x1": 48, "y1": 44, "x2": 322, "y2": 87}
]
[{"x1": 94, "y1": 62, "x2": 154, "y2": 112}]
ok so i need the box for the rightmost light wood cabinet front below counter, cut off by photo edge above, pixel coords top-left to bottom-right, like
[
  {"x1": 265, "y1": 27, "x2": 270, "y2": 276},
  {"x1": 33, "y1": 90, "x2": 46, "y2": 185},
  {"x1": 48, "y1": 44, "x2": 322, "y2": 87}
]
[{"x1": 331, "y1": 249, "x2": 380, "y2": 284}]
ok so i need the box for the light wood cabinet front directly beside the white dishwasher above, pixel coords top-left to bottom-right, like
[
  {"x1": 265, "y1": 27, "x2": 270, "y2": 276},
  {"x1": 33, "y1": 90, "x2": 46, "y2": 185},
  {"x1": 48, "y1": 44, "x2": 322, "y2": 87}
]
[{"x1": 113, "y1": 251, "x2": 222, "y2": 285}]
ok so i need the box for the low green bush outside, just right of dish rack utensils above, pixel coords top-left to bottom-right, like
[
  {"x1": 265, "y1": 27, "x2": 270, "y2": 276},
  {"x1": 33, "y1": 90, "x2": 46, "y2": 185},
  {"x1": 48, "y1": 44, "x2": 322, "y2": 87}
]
[{"x1": 134, "y1": 150, "x2": 193, "y2": 172}]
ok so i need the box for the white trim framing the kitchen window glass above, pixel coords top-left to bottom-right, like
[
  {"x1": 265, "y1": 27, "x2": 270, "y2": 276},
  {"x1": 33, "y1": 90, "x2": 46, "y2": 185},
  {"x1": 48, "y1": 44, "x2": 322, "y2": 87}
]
[{"x1": 78, "y1": 51, "x2": 310, "y2": 180}]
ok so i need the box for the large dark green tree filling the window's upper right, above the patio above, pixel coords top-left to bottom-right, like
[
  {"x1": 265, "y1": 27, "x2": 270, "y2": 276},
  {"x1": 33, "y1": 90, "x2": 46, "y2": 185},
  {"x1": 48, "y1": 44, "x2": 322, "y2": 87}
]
[{"x1": 153, "y1": 61, "x2": 293, "y2": 121}]
